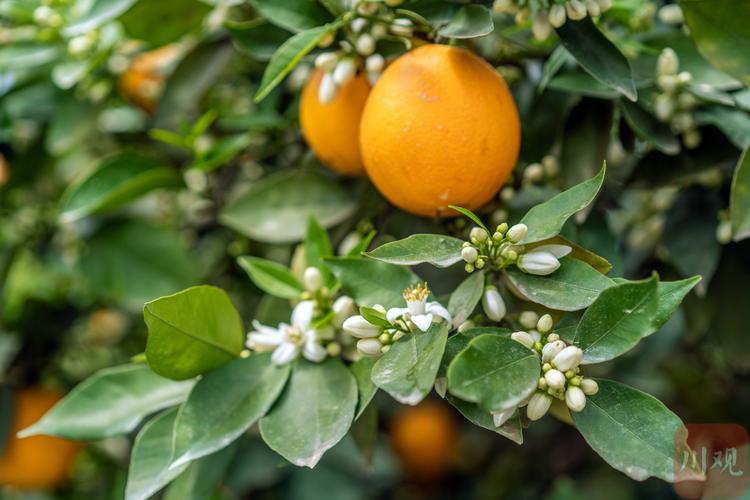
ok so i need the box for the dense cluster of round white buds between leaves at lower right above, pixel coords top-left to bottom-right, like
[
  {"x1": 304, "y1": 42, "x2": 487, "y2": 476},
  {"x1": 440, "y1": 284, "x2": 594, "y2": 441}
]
[{"x1": 511, "y1": 311, "x2": 599, "y2": 420}]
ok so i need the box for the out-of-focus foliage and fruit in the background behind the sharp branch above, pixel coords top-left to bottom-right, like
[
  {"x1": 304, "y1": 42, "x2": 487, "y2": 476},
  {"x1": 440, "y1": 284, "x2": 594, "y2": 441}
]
[{"x1": 0, "y1": 0, "x2": 750, "y2": 500}]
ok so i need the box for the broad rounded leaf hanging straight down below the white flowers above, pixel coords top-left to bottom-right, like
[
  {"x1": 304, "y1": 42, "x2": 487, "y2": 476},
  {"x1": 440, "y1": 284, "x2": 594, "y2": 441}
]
[{"x1": 260, "y1": 358, "x2": 357, "y2": 468}]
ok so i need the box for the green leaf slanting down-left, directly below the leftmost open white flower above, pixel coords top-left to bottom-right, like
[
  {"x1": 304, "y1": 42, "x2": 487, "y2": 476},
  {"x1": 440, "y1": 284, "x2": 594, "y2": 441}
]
[{"x1": 170, "y1": 354, "x2": 289, "y2": 467}]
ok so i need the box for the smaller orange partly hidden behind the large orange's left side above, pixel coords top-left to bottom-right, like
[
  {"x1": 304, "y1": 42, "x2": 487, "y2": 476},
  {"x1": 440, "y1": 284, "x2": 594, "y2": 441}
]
[{"x1": 299, "y1": 69, "x2": 370, "y2": 175}]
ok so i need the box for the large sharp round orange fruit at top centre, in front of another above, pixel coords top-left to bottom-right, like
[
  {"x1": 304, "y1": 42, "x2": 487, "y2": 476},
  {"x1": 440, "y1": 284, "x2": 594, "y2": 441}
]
[{"x1": 359, "y1": 44, "x2": 521, "y2": 216}]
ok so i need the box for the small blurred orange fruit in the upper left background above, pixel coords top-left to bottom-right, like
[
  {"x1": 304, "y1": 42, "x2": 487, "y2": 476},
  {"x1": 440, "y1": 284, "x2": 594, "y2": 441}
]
[{"x1": 119, "y1": 45, "x2": 182, "y2": 113}]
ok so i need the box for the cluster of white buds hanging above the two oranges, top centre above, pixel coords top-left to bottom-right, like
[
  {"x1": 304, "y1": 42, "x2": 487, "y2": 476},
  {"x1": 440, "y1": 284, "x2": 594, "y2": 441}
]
[{"x1": 315, "y1": 0, "x2": 414, "y2": 104}]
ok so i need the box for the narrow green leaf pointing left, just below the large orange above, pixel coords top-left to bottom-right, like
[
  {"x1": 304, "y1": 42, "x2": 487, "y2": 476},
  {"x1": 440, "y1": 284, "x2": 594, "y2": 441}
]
[{"x1": 366, "y1": 234, "x2": 464, "y2": 267}]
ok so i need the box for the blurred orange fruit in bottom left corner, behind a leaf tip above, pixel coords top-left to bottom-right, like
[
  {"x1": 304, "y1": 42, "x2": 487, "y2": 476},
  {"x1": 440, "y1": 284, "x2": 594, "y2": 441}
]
[{"x1": 0, "y1": 388, "x2": 79, "y2": 489}]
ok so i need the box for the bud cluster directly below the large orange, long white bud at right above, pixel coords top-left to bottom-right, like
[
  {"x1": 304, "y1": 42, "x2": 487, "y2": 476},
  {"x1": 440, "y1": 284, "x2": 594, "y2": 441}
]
[{"x1": 461, "y1": 222, "x2": 572, "y2": 276}]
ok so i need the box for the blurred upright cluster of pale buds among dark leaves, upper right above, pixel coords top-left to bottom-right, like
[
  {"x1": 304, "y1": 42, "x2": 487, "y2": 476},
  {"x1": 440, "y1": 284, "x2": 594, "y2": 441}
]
[{"x1": 654, "y1": 47, "x2": 701, "y2": 149}]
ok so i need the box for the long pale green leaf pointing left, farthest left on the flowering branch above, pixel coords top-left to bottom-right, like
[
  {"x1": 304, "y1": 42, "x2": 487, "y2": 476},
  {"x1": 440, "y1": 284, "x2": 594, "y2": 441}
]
[{"x1": 20, "y1": 364, "x2": 193, "y2": 440}]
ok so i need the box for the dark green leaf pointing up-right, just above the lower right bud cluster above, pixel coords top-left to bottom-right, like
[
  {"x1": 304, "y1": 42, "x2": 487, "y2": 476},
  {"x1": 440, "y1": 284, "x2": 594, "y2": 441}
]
[{"x1": 573, "y1": 275, "x2": 658, "y2": 364}]
